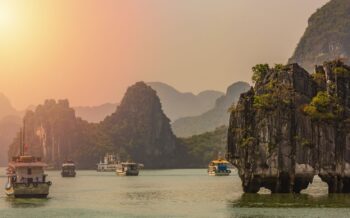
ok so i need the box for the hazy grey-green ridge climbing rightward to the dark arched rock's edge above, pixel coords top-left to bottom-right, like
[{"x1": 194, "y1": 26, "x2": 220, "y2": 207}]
[{"x1": 172, "y1": 82, "x2": 250, "y2": 137}]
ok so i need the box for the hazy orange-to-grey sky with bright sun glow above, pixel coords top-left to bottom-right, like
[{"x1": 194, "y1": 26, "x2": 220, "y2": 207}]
[{"x1": 0, "y1": 0, "x2": 328, "y2": 109}]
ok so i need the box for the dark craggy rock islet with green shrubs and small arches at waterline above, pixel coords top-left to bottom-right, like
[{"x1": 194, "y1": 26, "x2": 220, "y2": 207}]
[{"x1": 228, "y1": 61, "x2": 350, "y2": 193}]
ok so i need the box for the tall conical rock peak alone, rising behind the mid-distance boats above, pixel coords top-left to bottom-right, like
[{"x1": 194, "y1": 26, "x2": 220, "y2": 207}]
[{"x1": 101, "y1": 82, "x2": 186, "y2": 168}]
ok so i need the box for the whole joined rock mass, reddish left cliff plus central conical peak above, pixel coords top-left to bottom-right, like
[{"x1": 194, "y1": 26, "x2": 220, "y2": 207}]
[{"x1": 6, "y1": 82, "x2": 188, "y2": 169}]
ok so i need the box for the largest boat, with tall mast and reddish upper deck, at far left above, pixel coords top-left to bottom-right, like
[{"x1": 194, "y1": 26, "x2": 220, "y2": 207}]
[{"x1": 5, "y1": 122, "x2": 52, "y2": 198}]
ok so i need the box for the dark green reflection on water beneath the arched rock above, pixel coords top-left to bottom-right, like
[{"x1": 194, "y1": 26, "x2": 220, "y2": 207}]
[{"x1": 230, "y1": 194, "x2": 350, "y2": 208}]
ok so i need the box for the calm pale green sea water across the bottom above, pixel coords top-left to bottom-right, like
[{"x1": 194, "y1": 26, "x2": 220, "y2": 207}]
[{"x1": 0, "y1": 168, "x2": 350, "y2": 218}]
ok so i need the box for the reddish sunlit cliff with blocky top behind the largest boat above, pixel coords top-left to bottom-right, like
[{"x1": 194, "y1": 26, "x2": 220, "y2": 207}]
[{"x1": 8, "y1": 100, "x2": 98, "y2": 168}]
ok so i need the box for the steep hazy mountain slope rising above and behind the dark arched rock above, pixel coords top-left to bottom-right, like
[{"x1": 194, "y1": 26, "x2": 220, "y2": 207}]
[{"x1": 289, "y1": 0, "x2": 350, "y2": 70}]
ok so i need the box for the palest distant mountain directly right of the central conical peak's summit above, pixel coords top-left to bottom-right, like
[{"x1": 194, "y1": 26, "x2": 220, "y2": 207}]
[{"x1": 147, "y1": 82, "x2": 224, "y2": 121}]
